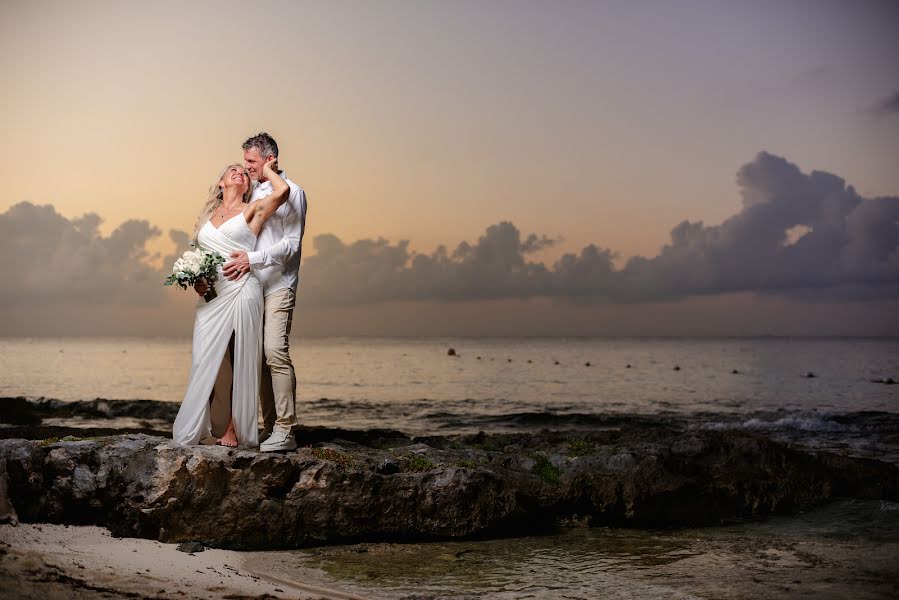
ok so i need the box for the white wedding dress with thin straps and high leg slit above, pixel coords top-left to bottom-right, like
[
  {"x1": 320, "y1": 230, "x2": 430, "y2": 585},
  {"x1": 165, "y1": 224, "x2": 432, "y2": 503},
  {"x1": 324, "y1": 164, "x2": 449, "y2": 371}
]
[{"x1": 172, "y1": 213, "x2": 263, "y2": 448}]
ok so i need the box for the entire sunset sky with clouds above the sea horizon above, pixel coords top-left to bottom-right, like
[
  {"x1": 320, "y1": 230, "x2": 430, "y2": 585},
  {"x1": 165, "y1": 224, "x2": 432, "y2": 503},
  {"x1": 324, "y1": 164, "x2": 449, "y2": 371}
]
[{"x1": 0, "y1": 0, "x2": 899, "y2": 335}]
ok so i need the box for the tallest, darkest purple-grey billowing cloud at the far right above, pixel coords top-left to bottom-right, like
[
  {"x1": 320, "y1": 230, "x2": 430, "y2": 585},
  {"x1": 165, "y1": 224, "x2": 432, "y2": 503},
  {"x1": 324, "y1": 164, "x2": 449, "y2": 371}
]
[{"x1": 620, "y1": 153, "x2": 899, "y2": 299}]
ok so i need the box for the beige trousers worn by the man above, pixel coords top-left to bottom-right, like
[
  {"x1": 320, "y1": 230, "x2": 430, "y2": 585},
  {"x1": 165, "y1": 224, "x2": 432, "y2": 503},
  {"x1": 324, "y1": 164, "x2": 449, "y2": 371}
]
[{"x1": 259, "y1": 288, "x2": 297, "y2": 431}]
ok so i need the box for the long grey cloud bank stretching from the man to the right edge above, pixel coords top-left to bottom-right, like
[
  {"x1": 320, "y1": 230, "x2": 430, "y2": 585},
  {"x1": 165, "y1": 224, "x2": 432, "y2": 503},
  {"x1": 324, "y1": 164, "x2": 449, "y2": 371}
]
[{"x1": 300, "y1": 152, "x2": 899, "y2": 306}]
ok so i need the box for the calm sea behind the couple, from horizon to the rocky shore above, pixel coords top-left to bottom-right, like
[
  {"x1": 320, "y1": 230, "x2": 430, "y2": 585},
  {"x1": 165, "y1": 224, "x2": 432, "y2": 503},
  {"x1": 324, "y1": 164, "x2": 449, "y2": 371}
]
[{"x1": 0, "y1": 338, "x2": 899, "y2": 432}]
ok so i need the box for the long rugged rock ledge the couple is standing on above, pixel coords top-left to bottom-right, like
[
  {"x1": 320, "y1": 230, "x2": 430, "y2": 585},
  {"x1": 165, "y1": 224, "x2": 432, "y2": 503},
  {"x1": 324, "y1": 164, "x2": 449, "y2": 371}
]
[{"x1": 0, "y1": 427, "x2": 899, "y2": 549}]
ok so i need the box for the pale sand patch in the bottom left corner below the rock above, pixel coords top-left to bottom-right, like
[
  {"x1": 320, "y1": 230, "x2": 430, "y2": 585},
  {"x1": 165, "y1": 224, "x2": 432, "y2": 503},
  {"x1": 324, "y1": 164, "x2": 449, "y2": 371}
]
[{"x1": 0, "y1": 524, "x2": 368, "y2": 600}]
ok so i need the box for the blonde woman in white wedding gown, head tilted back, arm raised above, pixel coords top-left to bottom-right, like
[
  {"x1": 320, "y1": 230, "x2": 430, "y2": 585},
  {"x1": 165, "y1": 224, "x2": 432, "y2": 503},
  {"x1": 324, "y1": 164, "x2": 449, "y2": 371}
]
[{"x1": 172, "y1": 159, "x2": 290, "y2": 448}]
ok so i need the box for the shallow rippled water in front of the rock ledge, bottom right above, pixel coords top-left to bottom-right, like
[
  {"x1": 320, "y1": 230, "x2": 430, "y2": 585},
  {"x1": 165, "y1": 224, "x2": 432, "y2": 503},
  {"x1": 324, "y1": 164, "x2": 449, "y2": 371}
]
[{"x1": 247, "y1": 500, "x2": 899, "y2": 599}]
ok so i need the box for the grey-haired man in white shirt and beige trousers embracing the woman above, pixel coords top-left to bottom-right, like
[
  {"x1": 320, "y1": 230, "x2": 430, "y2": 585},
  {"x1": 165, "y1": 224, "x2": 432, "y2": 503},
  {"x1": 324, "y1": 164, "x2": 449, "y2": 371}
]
[{"x1": 197, "y1": 133, "x2": 306, "y2": 452}]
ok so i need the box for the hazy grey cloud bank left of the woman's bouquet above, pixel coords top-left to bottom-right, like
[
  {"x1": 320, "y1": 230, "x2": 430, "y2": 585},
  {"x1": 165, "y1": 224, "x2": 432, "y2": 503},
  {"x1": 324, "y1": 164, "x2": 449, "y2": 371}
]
[{"x1": 0, "y1": 202, "x2": 163, "y2": 306}]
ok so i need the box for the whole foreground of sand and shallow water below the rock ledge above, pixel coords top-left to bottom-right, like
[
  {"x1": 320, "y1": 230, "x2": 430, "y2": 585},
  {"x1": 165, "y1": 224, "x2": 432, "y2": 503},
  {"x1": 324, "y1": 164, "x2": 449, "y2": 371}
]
[{"x1": 0, "y1": 504, "x2": 899, "y2": 600}]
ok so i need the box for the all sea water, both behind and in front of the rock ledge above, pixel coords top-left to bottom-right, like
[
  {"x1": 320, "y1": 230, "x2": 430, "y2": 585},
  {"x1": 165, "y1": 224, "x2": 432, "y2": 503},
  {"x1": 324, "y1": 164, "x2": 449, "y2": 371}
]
[{"x1": 0, "y1": 337, "x2": 899, "y2": 599}]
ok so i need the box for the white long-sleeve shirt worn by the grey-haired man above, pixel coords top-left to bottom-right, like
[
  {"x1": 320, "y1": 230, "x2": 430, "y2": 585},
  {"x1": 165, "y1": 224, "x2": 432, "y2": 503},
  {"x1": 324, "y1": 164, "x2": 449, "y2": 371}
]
[{"x1": 247, "y1": 173, "x2": 306, "y2": 296}]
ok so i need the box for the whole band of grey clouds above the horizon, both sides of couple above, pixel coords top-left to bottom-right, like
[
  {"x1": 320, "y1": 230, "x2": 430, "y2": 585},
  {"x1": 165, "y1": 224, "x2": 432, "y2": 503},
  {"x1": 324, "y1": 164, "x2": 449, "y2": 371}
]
[{"x1": 0, "y1": 152, "x2": 899, "y2": 308}]
